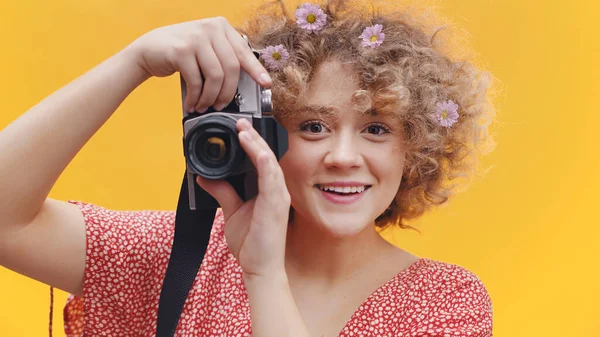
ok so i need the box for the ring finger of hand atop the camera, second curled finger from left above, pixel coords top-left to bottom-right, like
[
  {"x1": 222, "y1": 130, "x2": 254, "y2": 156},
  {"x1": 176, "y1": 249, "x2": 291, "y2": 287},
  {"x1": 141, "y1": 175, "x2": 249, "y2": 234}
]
[{"x1": 196, "y1": 43, "x2": 224, "y2": 112}]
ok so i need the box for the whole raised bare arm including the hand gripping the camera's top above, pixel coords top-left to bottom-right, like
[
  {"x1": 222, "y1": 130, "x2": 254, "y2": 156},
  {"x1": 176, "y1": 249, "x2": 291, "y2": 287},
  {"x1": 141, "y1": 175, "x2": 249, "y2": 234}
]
[{"x1": 0, "y1": 18, "x2": 271, "y2": 294}]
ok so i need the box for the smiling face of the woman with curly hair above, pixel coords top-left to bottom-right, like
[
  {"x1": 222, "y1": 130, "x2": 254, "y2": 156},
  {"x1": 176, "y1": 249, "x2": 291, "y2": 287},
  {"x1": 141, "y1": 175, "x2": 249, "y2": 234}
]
[{"x1": 280, "y1": 62, "x2": 405, "y2": 237}]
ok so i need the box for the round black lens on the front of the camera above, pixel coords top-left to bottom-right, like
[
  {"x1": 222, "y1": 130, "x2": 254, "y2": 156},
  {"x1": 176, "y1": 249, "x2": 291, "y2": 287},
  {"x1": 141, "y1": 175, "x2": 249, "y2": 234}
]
[{"x1": 184, "y1": 114, "x2": 245, "y2": 179}]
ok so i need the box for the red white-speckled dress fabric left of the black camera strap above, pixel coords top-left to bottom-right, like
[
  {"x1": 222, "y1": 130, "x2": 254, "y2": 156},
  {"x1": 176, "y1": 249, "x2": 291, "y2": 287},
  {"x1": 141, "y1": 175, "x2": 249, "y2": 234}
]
[{"x1": 63, "y1": 201, "x2": 175, "y2": 337}]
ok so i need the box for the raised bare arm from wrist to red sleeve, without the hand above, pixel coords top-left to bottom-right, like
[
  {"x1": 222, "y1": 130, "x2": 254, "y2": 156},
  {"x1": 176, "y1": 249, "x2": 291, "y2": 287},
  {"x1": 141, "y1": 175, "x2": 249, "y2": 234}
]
[{"x1": 0, "y1": 49, "x2": 148, "y2": 295}]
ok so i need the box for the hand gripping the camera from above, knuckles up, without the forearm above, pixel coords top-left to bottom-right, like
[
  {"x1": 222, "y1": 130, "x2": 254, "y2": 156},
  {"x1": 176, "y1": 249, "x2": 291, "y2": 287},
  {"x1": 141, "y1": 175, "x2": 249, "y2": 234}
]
[{"x1": 127, "y1": 17, "x2": 272, "y2": 113}]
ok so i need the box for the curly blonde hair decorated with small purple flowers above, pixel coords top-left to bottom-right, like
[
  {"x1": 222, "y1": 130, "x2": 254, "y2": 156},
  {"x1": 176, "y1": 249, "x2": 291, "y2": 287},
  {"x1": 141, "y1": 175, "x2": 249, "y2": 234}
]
[{"x1": 239, "y1": 0, "x2": 495, "y2": 228}]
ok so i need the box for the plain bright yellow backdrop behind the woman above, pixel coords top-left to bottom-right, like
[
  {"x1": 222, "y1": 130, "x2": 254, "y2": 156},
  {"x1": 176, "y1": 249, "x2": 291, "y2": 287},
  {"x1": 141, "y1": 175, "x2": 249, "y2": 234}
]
[{"x1": 0, "y1": 0, "x2": 600, "y2": 337}]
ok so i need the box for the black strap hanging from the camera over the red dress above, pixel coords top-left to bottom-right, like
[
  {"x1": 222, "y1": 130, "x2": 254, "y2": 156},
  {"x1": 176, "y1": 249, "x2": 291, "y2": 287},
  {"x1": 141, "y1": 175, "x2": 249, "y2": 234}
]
[{"x1": 156, "y1": 171, "x2": 216, "y2": 337}]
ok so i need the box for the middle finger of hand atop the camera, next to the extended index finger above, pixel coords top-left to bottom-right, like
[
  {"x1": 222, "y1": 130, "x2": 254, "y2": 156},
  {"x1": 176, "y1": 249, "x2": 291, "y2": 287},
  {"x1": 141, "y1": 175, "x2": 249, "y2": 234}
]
[{"x1": 212, "y1": 39, "x2": 240, "y2": 111}]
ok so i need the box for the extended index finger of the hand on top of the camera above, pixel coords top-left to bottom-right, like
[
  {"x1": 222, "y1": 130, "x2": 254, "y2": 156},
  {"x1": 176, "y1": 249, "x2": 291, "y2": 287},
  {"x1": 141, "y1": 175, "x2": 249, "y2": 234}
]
[{"x1": 226, "y1": 26, "x2": 273, "y2": 88}]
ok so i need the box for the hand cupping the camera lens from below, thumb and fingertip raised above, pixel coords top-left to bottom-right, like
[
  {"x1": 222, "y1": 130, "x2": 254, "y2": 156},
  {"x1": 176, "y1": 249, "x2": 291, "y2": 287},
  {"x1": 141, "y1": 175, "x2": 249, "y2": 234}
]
[{"x1": 196, "y1": 119, "x2": 290, "y2": 276}]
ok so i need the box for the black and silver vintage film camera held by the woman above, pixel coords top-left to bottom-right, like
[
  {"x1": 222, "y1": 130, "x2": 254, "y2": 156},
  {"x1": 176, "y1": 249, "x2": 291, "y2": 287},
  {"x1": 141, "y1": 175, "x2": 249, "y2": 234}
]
[{"x1": 181, "y1": 39, "x2": 288, "y2": 210}]
